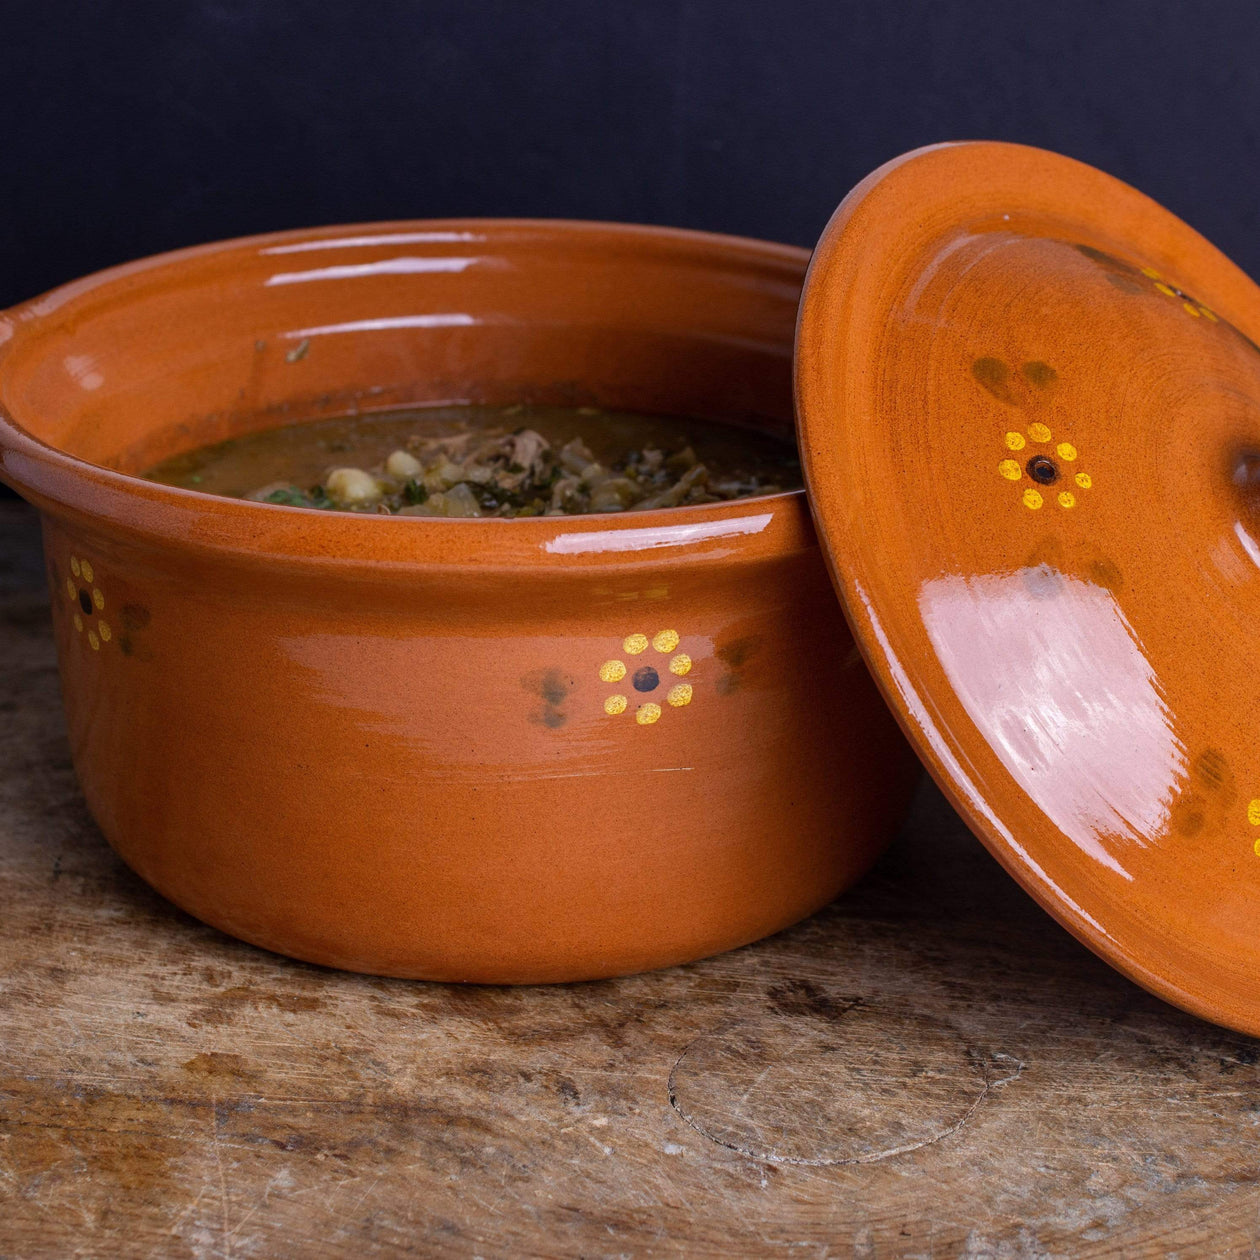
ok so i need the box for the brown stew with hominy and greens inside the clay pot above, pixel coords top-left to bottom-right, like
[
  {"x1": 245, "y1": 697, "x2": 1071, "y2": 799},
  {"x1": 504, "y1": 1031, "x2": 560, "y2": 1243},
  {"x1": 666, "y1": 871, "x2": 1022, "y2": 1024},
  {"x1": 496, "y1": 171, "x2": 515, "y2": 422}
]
[{"x1": 145, "y1": 406, "x2": 801, "y2": 517}]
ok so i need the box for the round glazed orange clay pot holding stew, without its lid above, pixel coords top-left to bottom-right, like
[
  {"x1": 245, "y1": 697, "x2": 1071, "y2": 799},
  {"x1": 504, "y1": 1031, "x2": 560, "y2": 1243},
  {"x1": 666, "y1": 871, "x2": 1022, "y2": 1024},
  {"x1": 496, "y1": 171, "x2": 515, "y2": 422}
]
[{"x1": 0, "y1": 222, "x2": 915, "y2": 982}]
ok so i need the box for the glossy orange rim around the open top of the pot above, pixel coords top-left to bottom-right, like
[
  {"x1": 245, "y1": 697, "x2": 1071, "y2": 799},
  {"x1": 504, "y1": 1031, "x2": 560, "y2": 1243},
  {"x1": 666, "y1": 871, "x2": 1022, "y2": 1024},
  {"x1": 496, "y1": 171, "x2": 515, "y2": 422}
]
[{"x1": 0, "y1": 218, "x2": 816, "y2": 570}]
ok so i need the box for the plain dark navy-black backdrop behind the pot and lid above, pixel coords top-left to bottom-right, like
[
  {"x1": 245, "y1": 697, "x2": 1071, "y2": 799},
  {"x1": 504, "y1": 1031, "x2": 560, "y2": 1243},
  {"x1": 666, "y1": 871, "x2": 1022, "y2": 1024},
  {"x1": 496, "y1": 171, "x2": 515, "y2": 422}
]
[{"x1": 0, "y1": 0, "x2": 1260, "y2": 306}]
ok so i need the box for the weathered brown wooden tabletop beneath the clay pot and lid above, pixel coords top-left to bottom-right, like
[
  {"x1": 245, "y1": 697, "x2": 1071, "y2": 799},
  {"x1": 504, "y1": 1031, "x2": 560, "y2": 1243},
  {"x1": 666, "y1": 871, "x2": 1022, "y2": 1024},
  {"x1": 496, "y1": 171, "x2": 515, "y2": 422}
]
[{"x1": 0, "y1": 503, "x2": 1260, "y2": 1257}]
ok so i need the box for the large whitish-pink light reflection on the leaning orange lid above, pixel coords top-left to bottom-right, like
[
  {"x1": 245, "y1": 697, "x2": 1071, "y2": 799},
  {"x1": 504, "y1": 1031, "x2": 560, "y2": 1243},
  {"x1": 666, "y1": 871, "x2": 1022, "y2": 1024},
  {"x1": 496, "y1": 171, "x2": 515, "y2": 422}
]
[{"x1": 919, "y1": 564, "x2": 1186, "y2": 879}]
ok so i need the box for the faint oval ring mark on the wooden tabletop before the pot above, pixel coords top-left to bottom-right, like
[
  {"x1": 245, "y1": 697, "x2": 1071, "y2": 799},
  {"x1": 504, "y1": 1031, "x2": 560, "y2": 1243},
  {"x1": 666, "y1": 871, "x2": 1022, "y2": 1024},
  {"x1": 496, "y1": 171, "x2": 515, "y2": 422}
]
[{"x1": 669, "y1": 1002, "x2": 1022, "y2": 1166}]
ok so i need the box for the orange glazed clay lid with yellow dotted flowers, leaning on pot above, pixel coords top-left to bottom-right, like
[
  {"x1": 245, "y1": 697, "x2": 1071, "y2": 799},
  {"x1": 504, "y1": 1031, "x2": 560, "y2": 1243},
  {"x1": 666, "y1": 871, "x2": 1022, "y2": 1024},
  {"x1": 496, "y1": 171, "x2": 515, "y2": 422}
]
[{"x1": 796, "y1": 144, "x2": 1260, "y2": 1033}]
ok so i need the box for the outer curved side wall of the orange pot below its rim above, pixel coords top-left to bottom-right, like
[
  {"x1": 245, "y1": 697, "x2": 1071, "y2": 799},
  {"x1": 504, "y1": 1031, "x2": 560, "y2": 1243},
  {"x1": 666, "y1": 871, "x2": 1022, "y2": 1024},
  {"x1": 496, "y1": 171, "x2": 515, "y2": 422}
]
[{"x1": 47, "y1": 506, "x2": 914, "y2": 983}]
